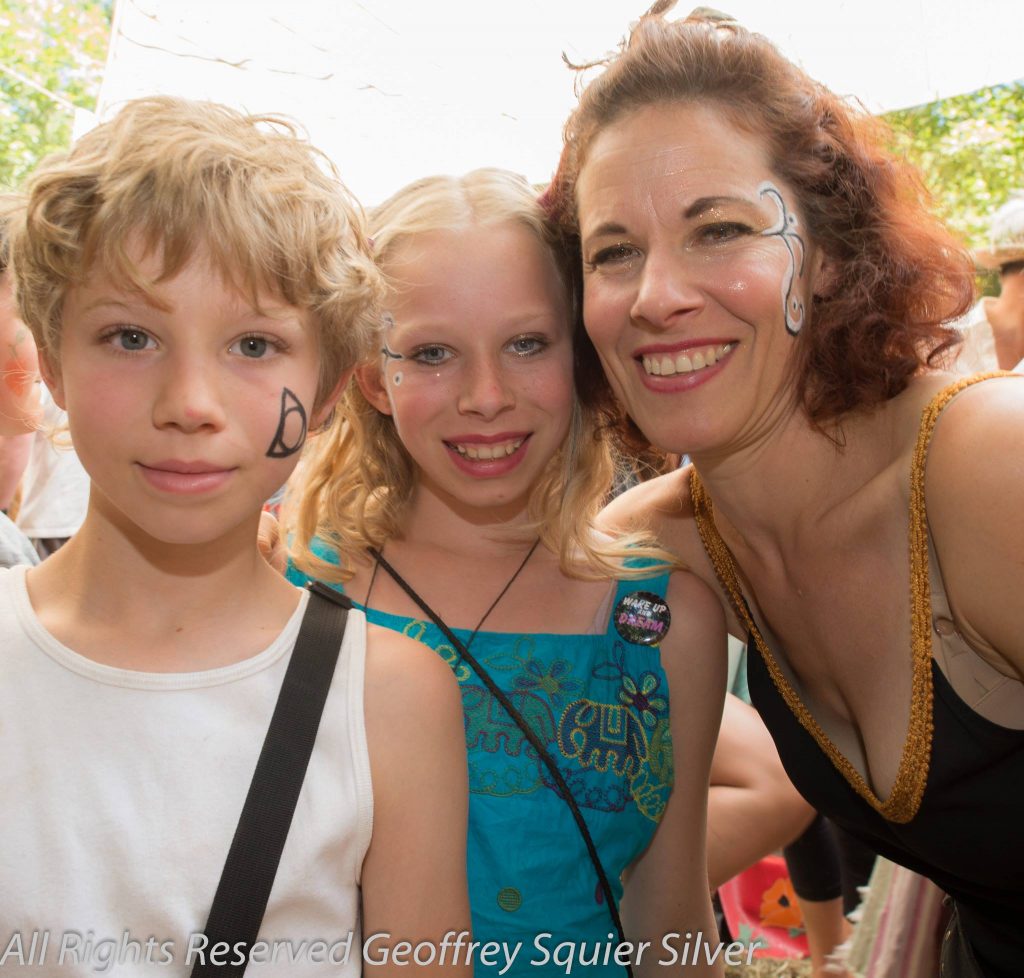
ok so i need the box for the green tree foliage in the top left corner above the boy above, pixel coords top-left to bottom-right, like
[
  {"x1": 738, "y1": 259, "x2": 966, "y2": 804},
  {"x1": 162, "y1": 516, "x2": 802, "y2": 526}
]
[{"x1": 0, "y1": 0, "x2": 112, "y2": 187}]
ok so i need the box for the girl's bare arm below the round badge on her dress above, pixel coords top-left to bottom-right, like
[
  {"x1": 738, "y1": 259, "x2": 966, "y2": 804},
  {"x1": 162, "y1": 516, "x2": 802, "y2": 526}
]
[{"x1": 623, "y1": 573, "x2": 726, "y2": 976}]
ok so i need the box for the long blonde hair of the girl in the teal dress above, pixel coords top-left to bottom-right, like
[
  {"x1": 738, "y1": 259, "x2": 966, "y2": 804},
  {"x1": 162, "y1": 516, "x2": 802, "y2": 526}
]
[{"x1": 289, "y1": 169, "x2": 677, "y2": 582}]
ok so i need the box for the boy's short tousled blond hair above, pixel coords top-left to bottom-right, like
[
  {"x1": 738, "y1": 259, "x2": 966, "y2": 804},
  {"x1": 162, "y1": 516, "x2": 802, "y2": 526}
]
[{"x1": 8, "y1": 96, "x2": 384, "y2": 407}]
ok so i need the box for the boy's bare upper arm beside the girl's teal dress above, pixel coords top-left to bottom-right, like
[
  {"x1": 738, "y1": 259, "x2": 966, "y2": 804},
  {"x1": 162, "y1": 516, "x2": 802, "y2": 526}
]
[{"x1": 362, "y1": 626, "x2": 472, "y2": 978}]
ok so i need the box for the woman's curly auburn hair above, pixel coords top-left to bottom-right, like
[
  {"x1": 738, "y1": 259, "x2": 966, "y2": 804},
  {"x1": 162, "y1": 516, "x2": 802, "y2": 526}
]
[{"x1": 545, "y1": 0, "x2": 974, "y2": 426}]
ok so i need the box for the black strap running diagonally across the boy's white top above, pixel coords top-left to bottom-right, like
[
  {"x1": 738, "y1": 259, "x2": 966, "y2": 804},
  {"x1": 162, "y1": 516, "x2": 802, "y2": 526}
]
[{"x1": 191, "y1": 582, "x2": 352, "y2": 978}]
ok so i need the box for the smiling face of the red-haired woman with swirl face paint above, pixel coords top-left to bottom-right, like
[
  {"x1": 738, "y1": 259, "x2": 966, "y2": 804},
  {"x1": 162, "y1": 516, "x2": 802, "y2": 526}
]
[{"x1": 577, "y1": 103, "x2": 819, "y2": 455}]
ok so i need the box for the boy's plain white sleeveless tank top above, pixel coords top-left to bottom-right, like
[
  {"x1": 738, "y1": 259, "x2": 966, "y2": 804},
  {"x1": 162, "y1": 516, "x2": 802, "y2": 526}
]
[{"x1": 0, "y1": 567, "x2": 373, "y2": 978}]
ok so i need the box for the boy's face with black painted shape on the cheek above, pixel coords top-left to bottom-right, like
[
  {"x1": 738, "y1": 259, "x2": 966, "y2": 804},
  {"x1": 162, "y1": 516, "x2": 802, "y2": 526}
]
[{"x1": 44, "y1": 251, "x2": 330, "y2": 544}]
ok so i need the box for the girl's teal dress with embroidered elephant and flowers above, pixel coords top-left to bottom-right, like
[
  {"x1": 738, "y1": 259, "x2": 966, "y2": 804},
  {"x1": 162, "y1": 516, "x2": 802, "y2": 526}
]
[{"x1": 288, "y1": 541, "x2": 673, "y2": 978}]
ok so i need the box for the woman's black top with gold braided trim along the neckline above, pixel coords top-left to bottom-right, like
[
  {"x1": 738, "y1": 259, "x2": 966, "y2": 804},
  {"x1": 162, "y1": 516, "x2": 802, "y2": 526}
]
[{"x1": 691, "y1": 379, "x2": 1024, "y2": 978}]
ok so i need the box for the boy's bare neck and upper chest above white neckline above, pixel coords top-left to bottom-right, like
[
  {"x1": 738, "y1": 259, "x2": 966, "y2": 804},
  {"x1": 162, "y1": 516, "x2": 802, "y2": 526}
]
[{"x1": 28, "y1": 506, "x2": 299, "y2": 673}]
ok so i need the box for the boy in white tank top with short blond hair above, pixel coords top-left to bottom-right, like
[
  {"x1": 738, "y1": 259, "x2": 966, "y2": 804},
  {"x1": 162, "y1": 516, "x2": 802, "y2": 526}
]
[{"x1": 0, "y1": 98, "x2": 468, "y2": 978}]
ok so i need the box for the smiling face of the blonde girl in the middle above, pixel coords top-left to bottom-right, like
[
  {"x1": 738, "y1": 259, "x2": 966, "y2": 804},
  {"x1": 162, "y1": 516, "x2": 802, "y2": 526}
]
[{"x1": 357, "y1": 222, "x2": 573, "y2": 518}]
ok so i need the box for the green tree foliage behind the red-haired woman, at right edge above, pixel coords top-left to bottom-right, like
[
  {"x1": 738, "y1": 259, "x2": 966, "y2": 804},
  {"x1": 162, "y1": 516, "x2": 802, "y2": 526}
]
[{"x1": 885, "y1": 81, "x2": 1024, "y2": 247}]
